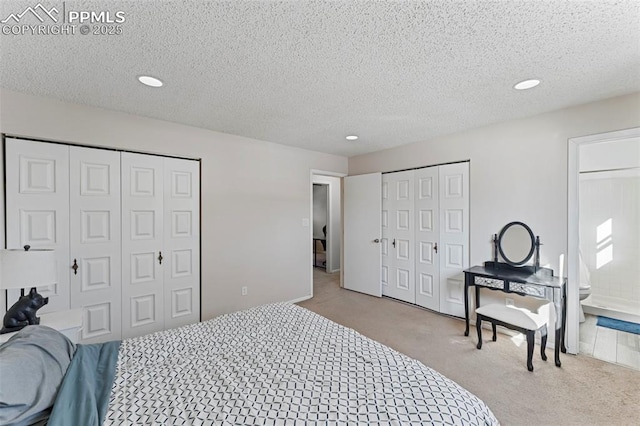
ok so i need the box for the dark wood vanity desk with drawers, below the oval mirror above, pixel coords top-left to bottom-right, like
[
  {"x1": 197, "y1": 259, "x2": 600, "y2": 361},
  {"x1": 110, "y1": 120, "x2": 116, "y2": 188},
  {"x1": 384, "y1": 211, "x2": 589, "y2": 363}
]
[{"x1": 464, "y1": 261, "x2": 567, "y2": 367}]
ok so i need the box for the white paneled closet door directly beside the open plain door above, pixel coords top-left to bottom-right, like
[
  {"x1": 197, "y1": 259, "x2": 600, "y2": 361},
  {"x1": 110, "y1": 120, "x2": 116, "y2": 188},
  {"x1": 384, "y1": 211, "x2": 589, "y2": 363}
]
[{"x1": 382, "y1": 170, "x2": 416, "y2": 303}]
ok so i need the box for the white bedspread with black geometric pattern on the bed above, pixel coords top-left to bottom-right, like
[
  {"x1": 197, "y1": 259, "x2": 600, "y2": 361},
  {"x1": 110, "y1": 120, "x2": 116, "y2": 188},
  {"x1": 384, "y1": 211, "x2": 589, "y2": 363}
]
[{"x1": 104, "y1": 303, "x2": 498, "y2": 425}]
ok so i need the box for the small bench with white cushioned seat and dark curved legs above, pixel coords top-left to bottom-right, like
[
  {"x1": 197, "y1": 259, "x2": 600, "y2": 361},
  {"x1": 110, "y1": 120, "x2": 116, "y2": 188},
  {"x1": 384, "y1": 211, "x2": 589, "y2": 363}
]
[{"x1": 476, "y1": 303, "x2": 547, "y2": 371}]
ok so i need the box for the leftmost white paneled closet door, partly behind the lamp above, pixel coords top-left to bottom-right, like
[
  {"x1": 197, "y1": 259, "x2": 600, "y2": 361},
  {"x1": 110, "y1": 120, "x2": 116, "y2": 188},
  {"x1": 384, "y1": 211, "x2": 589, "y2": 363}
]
[{"x1": 5, "y1": 138, "x2": 70, "y2": 313}]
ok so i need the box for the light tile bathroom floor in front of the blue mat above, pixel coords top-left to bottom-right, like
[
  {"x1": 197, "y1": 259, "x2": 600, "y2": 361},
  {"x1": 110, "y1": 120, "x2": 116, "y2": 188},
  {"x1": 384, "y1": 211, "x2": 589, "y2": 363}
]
[{"x1": 580, "y1": 314, "x2": 640, "y2": 370}]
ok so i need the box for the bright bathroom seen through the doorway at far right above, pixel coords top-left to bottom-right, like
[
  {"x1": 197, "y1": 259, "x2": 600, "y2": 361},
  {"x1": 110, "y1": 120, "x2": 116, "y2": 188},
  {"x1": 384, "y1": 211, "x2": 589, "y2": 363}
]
[{"x1": 578, "y1": 130, "x2": 640, "y2": 370}]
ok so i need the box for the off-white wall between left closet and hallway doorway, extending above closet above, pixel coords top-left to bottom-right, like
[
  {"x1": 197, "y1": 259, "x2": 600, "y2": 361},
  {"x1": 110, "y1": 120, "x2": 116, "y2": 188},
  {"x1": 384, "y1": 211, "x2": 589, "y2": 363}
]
[{"x1": 0, "y1": 89, "x2": 347, "y2": 319}]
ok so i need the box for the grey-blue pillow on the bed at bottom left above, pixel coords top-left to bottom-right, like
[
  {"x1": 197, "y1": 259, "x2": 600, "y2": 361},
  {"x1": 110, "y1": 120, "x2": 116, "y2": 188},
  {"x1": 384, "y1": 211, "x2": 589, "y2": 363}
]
[{"x1": 0, "y1": 325, "x2": 76, "y2": 425}]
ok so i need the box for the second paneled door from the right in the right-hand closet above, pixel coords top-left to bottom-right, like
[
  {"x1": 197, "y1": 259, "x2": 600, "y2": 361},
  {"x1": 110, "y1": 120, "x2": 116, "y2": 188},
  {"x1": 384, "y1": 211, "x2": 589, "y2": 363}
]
[{"x1": 414, "y1": 167, "x2": 440, "y2": 311}]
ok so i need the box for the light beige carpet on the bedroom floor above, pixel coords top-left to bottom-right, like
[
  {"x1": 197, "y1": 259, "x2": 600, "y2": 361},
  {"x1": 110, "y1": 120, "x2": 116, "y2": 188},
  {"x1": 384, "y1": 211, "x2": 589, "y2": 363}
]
[{"x1": 300, "y1": 268, "x2": 640, "y2": 425}]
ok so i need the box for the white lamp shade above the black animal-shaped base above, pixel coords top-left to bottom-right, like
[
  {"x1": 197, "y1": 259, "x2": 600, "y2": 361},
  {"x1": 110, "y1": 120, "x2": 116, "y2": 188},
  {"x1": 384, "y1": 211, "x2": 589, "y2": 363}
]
[{"x1": 0, "y1": 249, "x2": 58, "y2": 289}]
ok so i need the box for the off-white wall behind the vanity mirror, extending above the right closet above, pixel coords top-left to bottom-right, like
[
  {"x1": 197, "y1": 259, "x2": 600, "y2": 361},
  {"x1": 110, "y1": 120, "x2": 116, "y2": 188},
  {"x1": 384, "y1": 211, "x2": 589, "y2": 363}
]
[{"x1": 349, "y1": 93, "x2": 640, "y2": 348}]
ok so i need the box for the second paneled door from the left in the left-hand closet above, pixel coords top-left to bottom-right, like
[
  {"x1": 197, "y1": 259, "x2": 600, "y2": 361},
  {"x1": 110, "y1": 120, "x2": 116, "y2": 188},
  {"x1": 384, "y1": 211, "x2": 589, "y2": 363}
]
[{"x1": 67, "y1": 146, "x2": 122, "y2": 343}]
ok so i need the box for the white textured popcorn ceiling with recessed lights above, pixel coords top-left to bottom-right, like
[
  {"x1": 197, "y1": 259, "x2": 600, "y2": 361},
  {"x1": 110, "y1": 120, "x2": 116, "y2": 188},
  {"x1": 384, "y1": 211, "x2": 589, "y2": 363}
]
[{"x1": 0, "y1": 0, "x2": 640, "y2": 156}]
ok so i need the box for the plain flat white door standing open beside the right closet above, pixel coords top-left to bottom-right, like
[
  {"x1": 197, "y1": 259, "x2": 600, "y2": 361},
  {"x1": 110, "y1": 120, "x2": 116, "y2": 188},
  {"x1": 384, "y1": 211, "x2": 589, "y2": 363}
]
[{"x1": 343, "y1": 173, "x2": 382, "y2": 297}]
